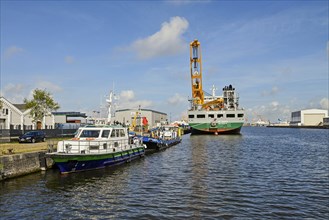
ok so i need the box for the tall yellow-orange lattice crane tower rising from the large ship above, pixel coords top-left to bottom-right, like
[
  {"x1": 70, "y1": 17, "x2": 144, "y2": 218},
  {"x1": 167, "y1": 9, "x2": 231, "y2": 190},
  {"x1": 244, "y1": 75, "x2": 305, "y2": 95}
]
[{"x1": 190, "y1": 40, "x2": 204, "y2": 105}]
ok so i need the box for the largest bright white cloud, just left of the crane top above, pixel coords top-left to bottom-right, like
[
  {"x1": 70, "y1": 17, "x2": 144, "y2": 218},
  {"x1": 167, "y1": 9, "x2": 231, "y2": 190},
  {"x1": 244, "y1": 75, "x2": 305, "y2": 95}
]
[{"x1": 131, "y1": 16, "x2": 189, "y2": 59}]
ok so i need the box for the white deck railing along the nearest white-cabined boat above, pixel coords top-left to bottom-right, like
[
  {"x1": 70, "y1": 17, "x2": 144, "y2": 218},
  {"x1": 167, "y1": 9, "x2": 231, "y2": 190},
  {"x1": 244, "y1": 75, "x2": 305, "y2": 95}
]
[{"x1": 57, "y1": 139, "x2": 141, "y2": 154}]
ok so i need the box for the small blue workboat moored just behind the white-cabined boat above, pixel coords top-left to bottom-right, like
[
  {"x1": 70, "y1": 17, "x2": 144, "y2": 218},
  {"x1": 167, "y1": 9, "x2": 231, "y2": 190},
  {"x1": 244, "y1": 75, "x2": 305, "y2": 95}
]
[{"x1": 143, "y1": 125, "x2": 182, "y2": 152}]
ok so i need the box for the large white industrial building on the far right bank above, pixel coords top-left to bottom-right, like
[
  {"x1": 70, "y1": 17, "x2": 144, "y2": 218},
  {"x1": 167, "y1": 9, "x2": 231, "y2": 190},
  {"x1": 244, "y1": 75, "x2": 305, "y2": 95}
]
[{"x1": 290, "y1": 109, "x2": 328, "y2": 126}]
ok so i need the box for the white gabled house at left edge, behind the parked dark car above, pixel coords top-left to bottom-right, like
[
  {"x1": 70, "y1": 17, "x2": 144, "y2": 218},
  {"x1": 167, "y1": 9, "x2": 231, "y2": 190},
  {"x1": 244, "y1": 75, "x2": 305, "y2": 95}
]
[{"x1": 0, "y1": 97, "x2": 55, "y2": 130}]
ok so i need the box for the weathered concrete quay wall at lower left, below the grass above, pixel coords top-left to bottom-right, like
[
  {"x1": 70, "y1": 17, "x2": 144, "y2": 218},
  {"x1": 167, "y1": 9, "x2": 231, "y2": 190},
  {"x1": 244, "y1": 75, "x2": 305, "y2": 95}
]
[{"x1": 0, "y1": 152, "x2": 52, "y2": 181}]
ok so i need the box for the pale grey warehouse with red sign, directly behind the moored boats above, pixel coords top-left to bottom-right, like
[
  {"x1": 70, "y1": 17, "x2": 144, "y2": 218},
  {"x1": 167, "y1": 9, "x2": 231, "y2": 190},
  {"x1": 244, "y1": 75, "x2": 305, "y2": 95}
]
[{"x1": 114, "y1": 109, "x2": 167, "y2": 128}]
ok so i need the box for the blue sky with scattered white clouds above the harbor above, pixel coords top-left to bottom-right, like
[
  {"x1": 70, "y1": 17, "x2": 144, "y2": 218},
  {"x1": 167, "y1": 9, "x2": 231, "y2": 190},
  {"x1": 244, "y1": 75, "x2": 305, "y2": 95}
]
[{"x1": 0, "y1": 0, "x2": 329, "y2": 122}]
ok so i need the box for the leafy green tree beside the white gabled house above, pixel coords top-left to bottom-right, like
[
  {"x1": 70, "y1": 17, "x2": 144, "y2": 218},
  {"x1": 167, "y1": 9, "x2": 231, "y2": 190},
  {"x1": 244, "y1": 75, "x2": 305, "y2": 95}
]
[{"x1": 24, "y1": 89, "x2": 60, "y2": 127}]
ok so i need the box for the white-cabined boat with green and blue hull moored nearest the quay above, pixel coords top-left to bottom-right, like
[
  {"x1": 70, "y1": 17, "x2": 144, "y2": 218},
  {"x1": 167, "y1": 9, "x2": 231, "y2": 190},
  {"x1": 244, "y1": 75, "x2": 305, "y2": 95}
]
[{"x1": 46, "y1": 125, "x2": 146, "y2": 174}]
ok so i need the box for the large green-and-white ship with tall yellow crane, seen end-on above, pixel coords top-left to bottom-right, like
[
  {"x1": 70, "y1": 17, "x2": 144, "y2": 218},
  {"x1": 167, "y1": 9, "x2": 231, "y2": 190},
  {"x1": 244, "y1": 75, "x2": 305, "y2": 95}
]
[{"x1": 188, "y1": 40, "x2": 244, "y2": 134}]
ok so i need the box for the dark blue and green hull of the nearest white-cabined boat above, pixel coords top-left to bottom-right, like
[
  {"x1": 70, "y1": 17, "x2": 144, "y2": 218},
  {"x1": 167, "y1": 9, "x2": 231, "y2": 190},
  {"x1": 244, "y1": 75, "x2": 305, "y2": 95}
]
[{"x1": 48, "y1": 147, "x2": 145, "y2": 174}]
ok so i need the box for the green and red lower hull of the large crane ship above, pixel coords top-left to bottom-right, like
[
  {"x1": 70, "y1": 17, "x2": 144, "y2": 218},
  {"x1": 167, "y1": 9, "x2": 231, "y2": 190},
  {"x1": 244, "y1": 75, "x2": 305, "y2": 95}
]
[{"x1": 189, "y1": 122, "x2": 243, "y2": 134}]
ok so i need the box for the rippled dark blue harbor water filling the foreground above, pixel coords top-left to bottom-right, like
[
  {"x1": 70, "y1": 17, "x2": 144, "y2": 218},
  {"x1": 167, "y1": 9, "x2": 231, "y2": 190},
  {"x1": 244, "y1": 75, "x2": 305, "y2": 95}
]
[{"x1": 0, "y1": 127, "x2": 329, "y2": 219}]
